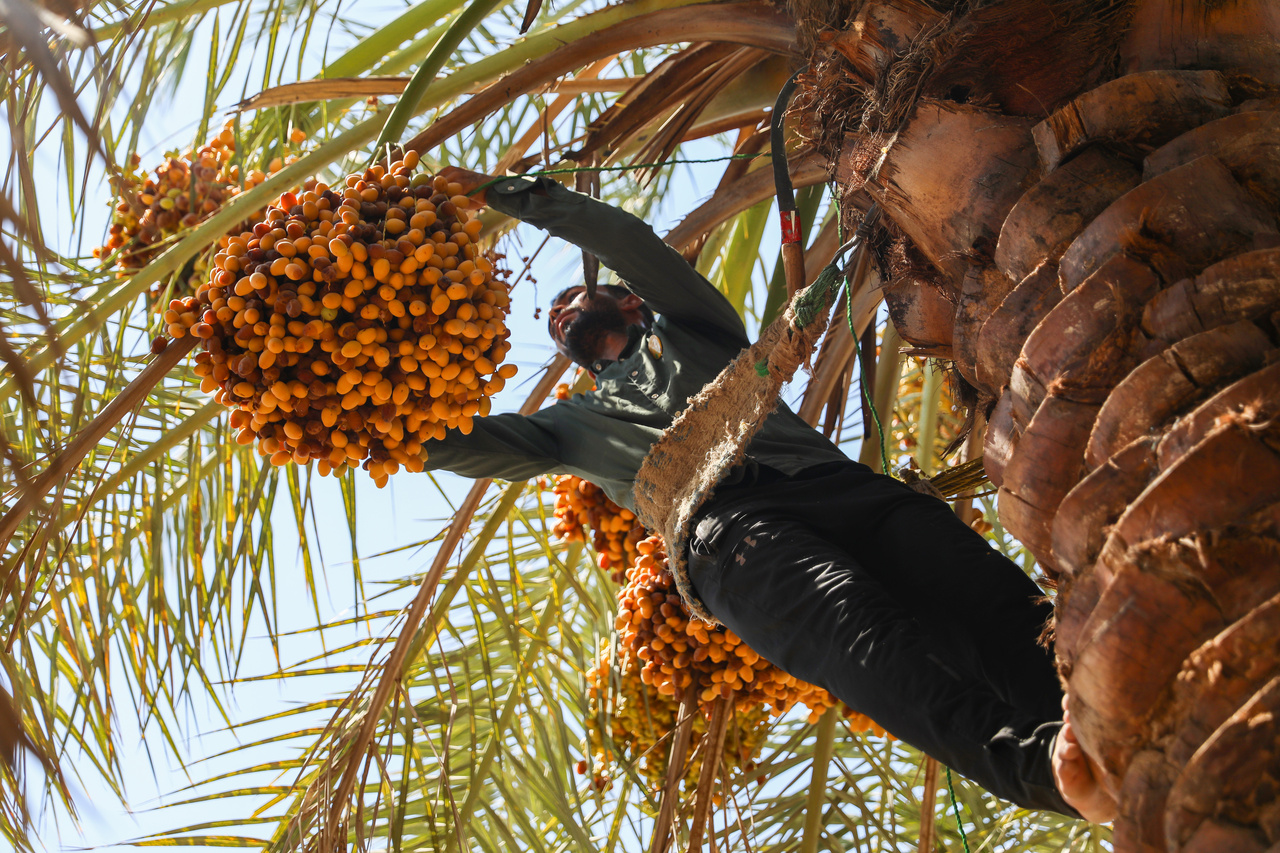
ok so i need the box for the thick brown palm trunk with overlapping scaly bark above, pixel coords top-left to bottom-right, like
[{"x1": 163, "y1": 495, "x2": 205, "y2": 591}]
[{"x1": 817, "y1": 0, "x2": 1280, "y2": 853}]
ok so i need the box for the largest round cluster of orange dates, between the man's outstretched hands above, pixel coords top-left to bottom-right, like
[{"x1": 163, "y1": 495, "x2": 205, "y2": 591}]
[{"x1": 164, "y1": 151, "x2": 516, "y2": 485}]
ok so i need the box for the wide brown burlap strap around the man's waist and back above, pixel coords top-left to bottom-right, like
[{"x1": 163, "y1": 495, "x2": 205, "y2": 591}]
[{"x1": 634, "y1": 282, "x2": 832, "y2": 622}]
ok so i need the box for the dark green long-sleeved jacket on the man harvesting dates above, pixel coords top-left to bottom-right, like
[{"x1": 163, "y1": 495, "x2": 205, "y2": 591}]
[{"x1": 422, "y1": 177, "x2": 847, "y2": 508}]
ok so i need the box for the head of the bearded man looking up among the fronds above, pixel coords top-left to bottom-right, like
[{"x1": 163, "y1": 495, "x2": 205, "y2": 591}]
[{"x1": 547, "y1": 284, "x2": 653, "y2": 368}]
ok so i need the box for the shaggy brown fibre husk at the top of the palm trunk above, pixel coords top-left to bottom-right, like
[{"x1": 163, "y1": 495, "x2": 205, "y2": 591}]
[{"x1": 790, "y1": 0, "x2": 1133, "y2": 167}]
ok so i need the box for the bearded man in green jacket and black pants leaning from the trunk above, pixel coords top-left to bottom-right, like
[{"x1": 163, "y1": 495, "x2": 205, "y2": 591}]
[{"x1": 424, "y1": 162, "x2": 1114, "y2": 821}]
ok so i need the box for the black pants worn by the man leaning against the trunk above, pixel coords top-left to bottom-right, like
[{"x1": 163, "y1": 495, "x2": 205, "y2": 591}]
[{"x1": 689, "y1": 461, "x2": 1076, "y2": 817}]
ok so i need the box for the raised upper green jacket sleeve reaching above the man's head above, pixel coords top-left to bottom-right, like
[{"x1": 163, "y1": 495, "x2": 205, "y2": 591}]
[{"x1": 486, "y1": 175, "x2": 749, "y2": 343}]
